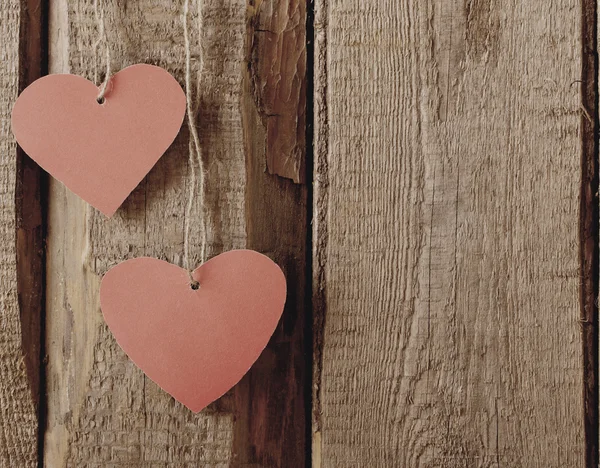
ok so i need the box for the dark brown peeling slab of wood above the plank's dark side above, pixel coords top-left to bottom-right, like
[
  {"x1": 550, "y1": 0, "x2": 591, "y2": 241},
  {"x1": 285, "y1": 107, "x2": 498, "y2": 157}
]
[{"x1": 250, "y1": 0, "x2": 306, "y2": 183}]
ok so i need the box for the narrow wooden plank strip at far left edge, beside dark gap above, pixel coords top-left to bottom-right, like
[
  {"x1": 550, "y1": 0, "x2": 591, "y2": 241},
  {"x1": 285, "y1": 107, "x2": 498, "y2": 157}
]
[{"x1": 0, "y1": 0, "x2": 39, "y2": 467}]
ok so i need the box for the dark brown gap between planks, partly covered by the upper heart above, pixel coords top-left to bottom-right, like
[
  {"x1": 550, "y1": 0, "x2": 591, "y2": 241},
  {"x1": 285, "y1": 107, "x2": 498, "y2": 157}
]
[{"x1": 15, "y1": 0, "x2": 48, "y2": 466}]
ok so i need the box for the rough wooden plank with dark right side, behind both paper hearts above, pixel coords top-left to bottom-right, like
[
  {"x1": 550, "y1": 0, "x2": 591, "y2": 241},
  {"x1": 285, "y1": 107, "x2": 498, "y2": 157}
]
[{"x1": 44, "y1": 0, "x2": 307, "y2": 467}]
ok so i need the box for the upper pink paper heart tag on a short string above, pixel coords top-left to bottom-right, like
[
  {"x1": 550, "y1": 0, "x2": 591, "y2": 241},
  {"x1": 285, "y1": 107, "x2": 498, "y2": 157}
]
[{"x1": 12, "y1": 64, "x2": 186, "y2": 216}]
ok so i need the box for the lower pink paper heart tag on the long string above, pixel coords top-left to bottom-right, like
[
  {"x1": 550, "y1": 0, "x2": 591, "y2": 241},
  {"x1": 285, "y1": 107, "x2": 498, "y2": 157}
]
[{"x1": 100, "y1": 250, "x2": 286, "y2": 412}]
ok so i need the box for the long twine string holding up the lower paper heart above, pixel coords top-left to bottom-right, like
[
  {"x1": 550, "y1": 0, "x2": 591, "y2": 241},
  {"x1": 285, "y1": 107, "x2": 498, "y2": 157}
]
[{"x1": 182, "y1": 0, "x2": 206, "y2": 289}]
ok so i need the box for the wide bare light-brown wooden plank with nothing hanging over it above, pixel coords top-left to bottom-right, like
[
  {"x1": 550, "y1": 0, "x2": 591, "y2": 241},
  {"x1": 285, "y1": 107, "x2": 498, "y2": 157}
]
[{"x1": 313, "y1": 0, "x2": 585, "y2": 467}]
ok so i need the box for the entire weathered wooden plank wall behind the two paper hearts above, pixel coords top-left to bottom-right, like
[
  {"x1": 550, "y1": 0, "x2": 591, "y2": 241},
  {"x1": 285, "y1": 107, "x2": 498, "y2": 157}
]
[{"x1": 0, "y1": 0, "x2": 598, "y2": 468}]
